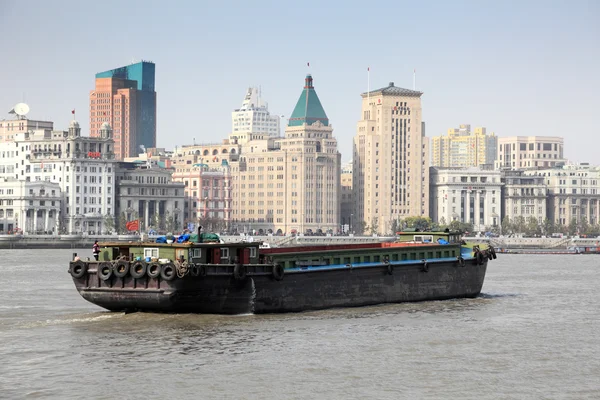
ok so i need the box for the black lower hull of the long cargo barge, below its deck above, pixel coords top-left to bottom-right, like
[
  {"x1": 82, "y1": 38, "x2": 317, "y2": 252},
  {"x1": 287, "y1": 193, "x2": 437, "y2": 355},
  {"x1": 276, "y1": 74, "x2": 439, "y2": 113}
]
[{"x1": 73, "y1": 259, "x2": 487, "y2": 314}]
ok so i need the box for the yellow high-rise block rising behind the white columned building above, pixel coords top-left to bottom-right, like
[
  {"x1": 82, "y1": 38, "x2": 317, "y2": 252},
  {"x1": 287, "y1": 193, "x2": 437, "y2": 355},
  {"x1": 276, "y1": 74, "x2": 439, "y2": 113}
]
[{"x1": 431, "y1": 124, "x2": 498, "y2": 168}]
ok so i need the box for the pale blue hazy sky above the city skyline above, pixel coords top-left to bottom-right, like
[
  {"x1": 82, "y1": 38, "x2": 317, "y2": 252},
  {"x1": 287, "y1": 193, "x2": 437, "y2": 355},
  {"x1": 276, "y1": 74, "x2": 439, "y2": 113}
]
[{"x1": 0, "y1": 0, "x2": 600, "y2": 164}]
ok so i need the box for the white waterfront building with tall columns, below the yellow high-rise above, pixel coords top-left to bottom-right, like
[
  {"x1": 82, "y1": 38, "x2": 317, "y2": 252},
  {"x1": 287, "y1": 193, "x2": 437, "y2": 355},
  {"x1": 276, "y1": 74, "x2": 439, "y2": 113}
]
[{"x1": 430, "y1": 167, "x2": 503, "y2": 232}]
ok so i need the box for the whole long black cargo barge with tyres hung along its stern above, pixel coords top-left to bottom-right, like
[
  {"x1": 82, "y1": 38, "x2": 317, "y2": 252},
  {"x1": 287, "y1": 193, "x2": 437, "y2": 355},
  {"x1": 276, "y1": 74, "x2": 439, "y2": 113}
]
[{"x1": 69, "y1": 231, "x2": 496, "y2": 314}]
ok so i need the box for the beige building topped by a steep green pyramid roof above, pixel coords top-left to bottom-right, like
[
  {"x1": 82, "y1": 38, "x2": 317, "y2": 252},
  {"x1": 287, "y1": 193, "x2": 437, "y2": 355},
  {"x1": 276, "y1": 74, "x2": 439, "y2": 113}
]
[{"x1": 229, "y1": 75, "x2": 341, "y2": 234}]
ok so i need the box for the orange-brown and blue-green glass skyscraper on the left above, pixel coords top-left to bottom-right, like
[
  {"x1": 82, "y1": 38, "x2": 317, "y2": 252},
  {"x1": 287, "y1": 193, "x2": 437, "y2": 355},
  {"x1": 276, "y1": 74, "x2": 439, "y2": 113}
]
[{"x1": 90, "y1": 61, "x2": 156, "y2": 160}]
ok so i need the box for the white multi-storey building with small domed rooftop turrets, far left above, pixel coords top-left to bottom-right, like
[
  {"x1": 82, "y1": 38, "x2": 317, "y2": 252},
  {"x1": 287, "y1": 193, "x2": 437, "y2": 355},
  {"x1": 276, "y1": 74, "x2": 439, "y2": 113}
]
[{"x1": 0, "y1": 120, "x2": 115, "y2": 233}]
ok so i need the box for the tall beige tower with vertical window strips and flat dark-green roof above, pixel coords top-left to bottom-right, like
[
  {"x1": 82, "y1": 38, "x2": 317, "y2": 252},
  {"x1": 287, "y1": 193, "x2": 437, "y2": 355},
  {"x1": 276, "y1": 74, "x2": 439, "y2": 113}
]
[{"x1": 352, "y1": 82, "x2": 429, "y2": 233}]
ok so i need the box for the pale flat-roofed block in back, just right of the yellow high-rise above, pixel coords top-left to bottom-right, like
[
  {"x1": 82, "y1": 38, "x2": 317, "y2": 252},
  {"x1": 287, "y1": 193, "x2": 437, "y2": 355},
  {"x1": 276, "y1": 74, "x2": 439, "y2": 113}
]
[{"x1": 495, "y1": 136, "x2": 566, "y2": 169}]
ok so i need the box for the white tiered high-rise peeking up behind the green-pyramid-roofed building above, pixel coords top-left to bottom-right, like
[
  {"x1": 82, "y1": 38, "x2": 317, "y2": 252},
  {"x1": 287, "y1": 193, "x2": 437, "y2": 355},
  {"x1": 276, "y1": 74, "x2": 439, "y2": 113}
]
[{"x1": 231, "y1": 87, "x2": 280, "y2": 136}]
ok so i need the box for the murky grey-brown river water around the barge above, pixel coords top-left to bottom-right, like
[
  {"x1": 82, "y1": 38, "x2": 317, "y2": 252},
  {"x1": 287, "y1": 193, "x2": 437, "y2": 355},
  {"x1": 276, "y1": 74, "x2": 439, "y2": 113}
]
[{"x1": 0, "y1": 249, "x2": 600, "y2": 399}]
